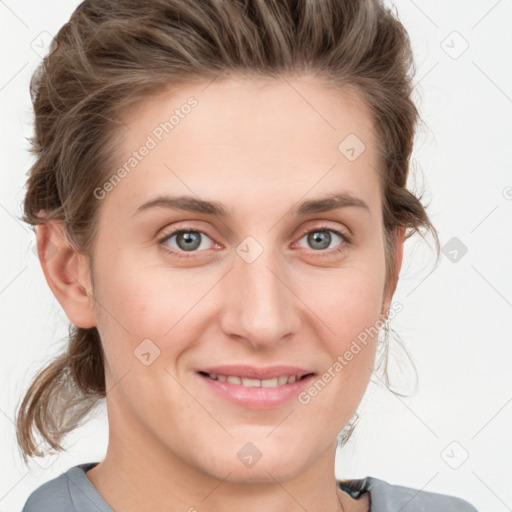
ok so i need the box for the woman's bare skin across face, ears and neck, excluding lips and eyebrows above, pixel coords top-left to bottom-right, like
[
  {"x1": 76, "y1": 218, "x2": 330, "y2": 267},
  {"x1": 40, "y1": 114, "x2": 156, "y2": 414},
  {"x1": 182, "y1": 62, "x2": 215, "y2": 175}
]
[{"x1": 38, "y1": 77, "x2": 404, "y2": 512}]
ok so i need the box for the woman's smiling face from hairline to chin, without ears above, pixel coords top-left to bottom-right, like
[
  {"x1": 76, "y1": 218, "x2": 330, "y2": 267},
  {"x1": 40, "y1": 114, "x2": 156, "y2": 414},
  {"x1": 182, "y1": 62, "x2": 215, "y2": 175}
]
[{"x1": 85, "y1": 78, "x2": 400, "y2": 482}]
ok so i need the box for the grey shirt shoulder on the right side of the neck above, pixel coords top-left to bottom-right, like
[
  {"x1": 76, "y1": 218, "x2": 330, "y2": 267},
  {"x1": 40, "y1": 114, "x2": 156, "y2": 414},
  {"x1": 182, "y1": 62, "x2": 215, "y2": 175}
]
[{"x1": 365, "y1": 476, "x2": 478, "y2": 512}]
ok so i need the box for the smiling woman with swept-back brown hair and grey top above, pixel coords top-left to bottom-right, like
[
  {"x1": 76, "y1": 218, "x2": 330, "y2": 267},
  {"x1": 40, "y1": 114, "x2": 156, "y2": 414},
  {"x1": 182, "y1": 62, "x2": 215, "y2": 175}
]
[{"x1": 17, "y1": 0, "x2": 475, "y2": 512}]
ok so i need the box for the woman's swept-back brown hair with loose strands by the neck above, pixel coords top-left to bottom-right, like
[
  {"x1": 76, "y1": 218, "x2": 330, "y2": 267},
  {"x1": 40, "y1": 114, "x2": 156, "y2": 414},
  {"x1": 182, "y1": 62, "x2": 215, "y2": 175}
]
[{"x1": 17, "y1": 0, "x2": 439, "y2": 461}]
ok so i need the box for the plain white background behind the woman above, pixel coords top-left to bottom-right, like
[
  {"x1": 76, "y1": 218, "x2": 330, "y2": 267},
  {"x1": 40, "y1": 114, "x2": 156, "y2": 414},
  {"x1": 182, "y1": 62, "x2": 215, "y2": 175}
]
[{"x1": 0, "y1": 0, "x2": 512, "y2": 512}]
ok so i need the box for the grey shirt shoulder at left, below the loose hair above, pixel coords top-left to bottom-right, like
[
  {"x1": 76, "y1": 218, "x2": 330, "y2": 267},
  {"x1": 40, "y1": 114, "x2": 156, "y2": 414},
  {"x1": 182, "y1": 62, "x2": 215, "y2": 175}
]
[{"x1": 22, "y1": 462, "x2": 112, "y2": 512}]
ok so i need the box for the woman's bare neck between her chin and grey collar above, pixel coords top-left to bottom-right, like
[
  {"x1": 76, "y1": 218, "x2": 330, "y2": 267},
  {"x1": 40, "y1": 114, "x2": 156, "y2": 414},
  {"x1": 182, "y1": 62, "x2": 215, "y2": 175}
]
[{"x1": 87, "y1": 400, "x2": 350, "y2": 512}]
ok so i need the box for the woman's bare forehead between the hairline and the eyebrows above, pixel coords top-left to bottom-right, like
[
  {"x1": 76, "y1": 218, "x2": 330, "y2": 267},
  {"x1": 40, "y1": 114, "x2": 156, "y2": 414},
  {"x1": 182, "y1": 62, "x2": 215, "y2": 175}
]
[{"x1": 107, "y1": 77, "x2": 378, "y2": 218}]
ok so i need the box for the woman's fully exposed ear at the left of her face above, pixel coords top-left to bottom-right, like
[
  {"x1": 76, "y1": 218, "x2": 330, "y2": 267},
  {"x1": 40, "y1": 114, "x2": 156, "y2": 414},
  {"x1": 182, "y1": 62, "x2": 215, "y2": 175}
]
[{"x1": 36, "y1": 220, "x2": 96, "y2": 328}]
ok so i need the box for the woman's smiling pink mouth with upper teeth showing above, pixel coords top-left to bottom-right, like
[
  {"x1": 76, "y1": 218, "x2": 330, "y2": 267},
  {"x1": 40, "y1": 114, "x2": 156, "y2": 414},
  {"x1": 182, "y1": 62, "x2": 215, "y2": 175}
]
[{"x1": 197, "y1": 366, "x2": 316, "y2": 409}]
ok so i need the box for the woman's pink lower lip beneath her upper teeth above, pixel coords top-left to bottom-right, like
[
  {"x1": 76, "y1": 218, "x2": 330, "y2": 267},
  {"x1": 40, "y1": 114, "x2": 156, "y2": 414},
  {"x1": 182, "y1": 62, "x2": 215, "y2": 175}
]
[{"x1": 198, "y1": 374, "x2": 314, "y2": 409}]
